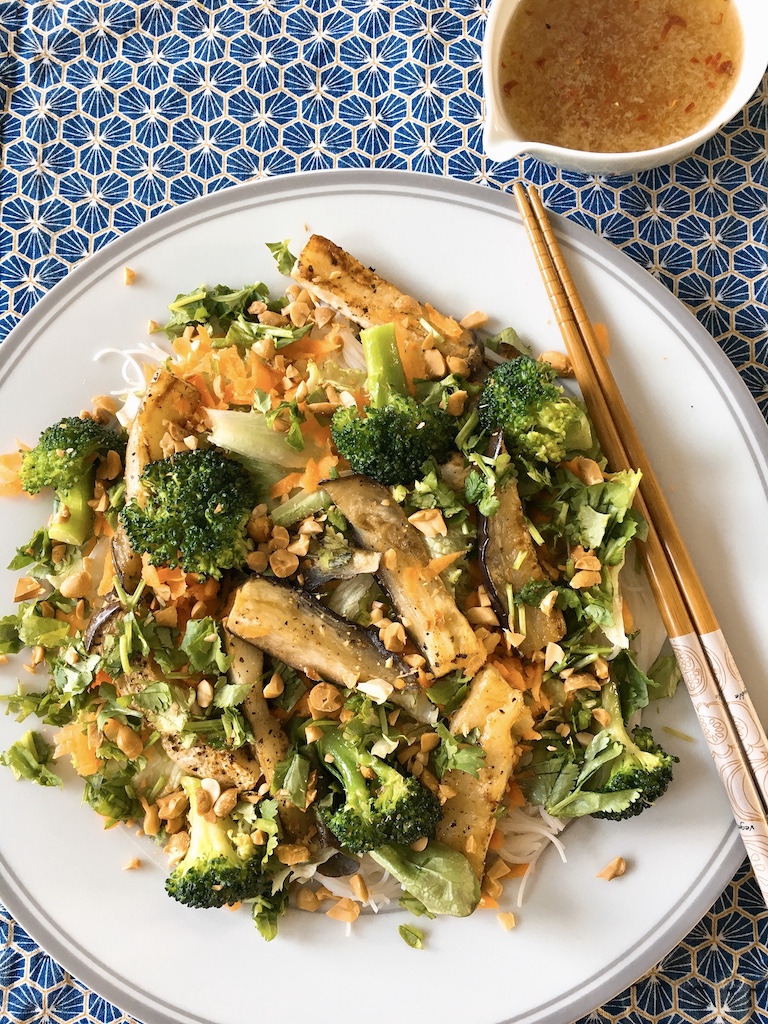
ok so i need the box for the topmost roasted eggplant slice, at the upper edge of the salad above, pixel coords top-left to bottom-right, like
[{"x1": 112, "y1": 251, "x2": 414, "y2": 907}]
[{"x1": 291, "y1": 234, "x2": 482, "y2": 374}]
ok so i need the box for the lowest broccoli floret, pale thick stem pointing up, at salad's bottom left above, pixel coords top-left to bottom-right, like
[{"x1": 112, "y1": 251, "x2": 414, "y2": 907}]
[{"x1": 165, "y1": 776, "x2": 272, "y2": 907}]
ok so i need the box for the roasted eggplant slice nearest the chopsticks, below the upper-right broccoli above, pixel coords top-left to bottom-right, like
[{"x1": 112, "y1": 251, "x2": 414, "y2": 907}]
[{"x1": 479, "y1": 441, "x2": 565, "y2": 657}]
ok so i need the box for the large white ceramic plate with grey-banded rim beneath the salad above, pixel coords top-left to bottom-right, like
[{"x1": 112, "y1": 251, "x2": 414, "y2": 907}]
[{"x1": 0, "y1": 171, "x2": 768, "y2": 1024}]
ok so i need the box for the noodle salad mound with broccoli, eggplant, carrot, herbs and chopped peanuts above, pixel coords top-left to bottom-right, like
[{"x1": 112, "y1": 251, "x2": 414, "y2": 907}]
[{"x1": 0, "y1": 236, "x2": 677, "y2": 941}]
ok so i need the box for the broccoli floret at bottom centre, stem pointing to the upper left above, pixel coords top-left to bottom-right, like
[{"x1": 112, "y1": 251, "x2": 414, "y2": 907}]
[{"x1": 316, "y1": 728, "x2": 441, "y2": 853}]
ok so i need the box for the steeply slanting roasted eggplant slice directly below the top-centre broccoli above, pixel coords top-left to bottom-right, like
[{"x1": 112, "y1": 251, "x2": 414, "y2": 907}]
[{"x1": 324, "y1": 476, "x2": 485, "y2": 677}]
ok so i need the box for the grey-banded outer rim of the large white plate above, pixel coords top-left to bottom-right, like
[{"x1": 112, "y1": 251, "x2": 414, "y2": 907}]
[{"x1": 0, "y1": 168, "x2": 768, "y2": 1024}]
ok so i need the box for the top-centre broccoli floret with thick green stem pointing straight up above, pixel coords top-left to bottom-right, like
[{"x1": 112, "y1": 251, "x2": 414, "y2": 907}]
[{"x1": 331, "y1": 324, "x2": 457, "y2": 484}]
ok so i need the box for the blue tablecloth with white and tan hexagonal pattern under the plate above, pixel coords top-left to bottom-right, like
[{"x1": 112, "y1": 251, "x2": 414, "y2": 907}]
[{"x1": 0, "y1": 0, "x2": 768, "y2": 1024}]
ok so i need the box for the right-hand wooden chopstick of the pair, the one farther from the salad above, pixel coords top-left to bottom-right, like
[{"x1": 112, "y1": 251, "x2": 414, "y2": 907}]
[{"x1": 528, "y1": 180, "x2": 768, "y2": 807}]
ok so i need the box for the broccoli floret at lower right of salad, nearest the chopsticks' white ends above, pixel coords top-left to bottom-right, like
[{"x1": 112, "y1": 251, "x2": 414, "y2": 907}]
[{"x1": 593, "y1": 683, "x2": 679, "y2": 821}]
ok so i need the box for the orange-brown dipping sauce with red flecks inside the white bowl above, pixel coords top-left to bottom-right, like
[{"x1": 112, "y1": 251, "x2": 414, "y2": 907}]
[{"x1": 500, "y1": 0, "x2": 742, "y2": 153}]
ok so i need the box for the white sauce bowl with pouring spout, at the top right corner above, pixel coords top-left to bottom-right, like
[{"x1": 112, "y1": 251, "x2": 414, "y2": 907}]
[{"x1": 482, "y1": 0, "x2": 768, "y2": 174}]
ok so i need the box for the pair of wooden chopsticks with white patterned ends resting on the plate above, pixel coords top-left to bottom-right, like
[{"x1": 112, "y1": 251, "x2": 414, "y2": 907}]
[{"x1": 513, "y1": 182, "x2": 768, "y2": 905}]
